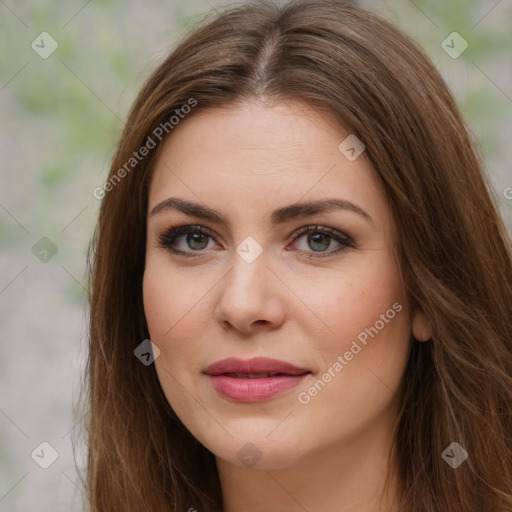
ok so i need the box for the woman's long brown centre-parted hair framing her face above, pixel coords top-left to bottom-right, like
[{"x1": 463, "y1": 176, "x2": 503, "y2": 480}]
[{"x1": 80, "y1": 0, "x2": 512, "y2": 512}]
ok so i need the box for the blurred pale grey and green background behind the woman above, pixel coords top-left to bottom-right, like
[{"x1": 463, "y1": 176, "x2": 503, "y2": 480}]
[{"x1": 0, "y1": 0, "x2": 512, "y2": 512}]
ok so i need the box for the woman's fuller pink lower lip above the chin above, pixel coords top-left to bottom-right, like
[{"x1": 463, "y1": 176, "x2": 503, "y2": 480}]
[{"x1": 209, "y1": 373, "x2": 309, "y2": 402}]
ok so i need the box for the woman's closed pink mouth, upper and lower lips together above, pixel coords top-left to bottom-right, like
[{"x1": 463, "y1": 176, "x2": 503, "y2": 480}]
[{"x1": 204, "y1": 357, "x2": 311, "y2": 402}]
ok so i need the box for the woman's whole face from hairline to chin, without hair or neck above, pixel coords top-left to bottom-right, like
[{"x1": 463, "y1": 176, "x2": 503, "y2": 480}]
[{"x1": 143, "y1": 101, "x2": 424, "y2": 469}]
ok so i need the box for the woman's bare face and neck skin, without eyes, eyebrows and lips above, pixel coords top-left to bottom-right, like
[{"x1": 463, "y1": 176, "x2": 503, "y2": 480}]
[{"x1": 143, "y1": 100, "x2": 430, "y2": 512}]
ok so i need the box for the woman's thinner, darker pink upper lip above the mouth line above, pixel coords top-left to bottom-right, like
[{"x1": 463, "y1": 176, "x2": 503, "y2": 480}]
[{"x1": 204, "y1": 357, "x2": 310, "y2": 375}]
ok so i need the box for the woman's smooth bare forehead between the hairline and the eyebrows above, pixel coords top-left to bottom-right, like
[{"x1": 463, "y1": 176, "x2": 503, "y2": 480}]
[{"x1": 149, "y1": 101, "x2": 386, "y2": 227}]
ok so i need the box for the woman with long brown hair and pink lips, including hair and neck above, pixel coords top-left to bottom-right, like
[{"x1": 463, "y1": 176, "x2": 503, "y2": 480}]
[{"x1": 83, "y1": 0, "x2": 512, "y2": 512}]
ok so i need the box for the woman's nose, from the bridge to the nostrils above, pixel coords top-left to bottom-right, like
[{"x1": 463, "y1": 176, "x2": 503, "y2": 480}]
[{"x1": 215, "y1": 246, "x2": 286, "y2": 334}]
